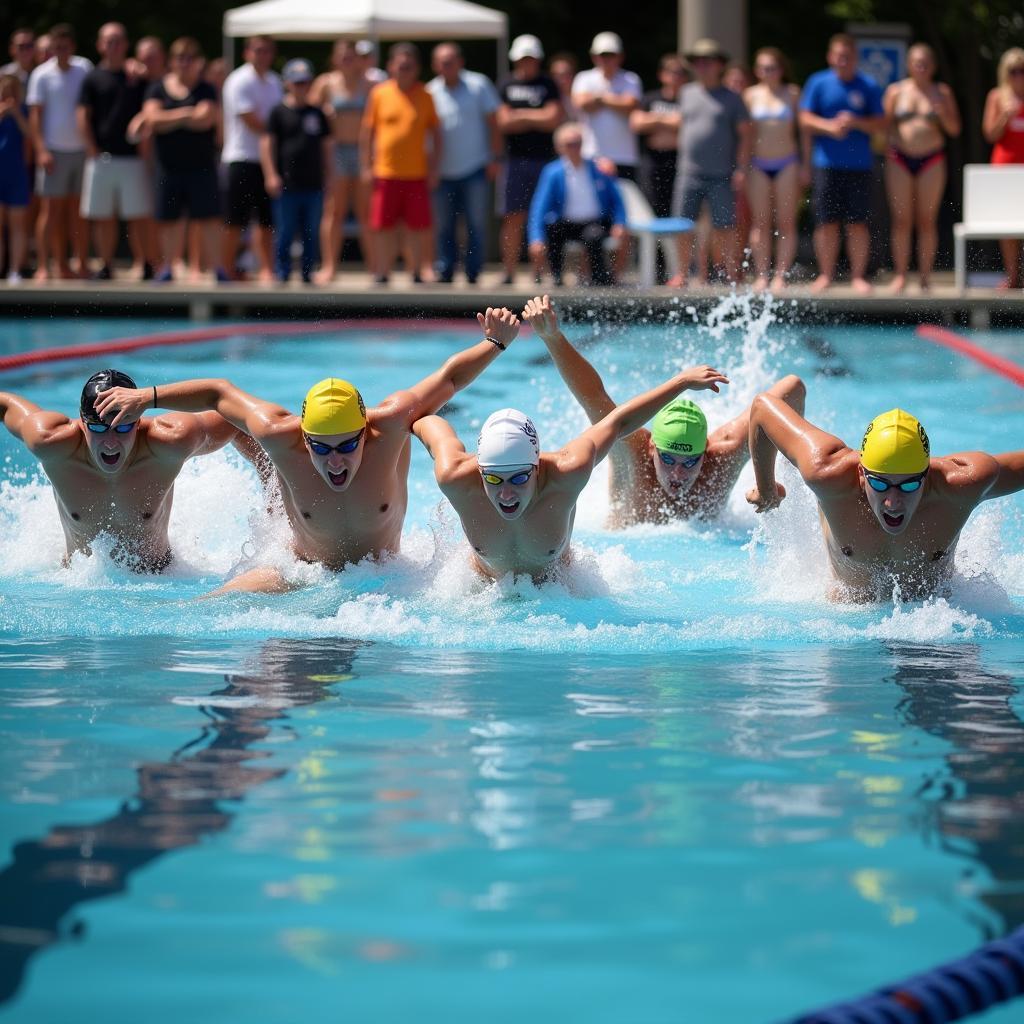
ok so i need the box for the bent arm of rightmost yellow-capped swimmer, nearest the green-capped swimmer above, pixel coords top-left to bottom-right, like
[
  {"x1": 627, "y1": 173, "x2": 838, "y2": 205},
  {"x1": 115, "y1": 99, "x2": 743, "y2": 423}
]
[{"x1": 746, "y1": 392, "x2": 850, "y2": 512}]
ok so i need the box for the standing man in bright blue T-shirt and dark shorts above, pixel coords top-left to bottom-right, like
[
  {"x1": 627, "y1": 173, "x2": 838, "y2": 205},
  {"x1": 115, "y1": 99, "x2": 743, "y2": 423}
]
[{"x1": 800, "y1": 34, "x2": 885, "y2": 295}]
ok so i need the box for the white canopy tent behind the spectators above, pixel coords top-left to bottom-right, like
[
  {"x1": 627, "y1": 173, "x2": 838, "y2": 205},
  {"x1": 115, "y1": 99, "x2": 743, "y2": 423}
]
[{"x1": 223, "y1": 0, "x2": 508, "y2": 70}]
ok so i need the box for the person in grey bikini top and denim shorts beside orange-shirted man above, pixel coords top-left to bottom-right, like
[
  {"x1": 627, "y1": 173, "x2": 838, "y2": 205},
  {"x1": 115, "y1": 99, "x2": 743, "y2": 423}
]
[{"x1": 309, "y1": 39, "x2": 372, "y2": 284}]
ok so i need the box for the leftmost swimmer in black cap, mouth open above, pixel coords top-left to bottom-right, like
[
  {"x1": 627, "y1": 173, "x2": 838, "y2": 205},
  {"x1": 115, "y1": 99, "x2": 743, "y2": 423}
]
[{"x1": 0, "y1": 370, "x2": 238, "y2": 572}]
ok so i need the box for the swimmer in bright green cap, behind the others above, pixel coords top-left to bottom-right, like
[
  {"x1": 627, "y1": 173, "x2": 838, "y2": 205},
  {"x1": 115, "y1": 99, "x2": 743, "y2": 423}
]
[{"x1": 522, "y1": 295, "x2": 805, "y2": 529}]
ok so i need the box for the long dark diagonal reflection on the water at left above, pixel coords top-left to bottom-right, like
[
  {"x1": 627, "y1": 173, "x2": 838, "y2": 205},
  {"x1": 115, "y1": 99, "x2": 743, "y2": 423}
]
[{"x1": 0, "y1": 639, "x2": 364, "y2": 1004}]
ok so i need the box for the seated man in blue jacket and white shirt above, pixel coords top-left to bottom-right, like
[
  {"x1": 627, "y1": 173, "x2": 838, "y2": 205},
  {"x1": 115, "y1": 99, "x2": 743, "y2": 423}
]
[{"x1": 528, "y1": 121, "x2": 626, "y2": 287}]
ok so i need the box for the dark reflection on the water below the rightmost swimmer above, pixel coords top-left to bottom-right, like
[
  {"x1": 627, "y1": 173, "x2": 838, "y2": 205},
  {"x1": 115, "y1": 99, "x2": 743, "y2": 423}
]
[{"x1": 890, "y1": 644, "x2": 1024, "y2": 939}]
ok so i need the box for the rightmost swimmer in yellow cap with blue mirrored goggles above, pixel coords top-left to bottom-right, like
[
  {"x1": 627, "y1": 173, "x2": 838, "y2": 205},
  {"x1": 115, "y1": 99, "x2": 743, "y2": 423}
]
[{"x1": 746, "y1": 394, "x2": 1024, "y2": 601}]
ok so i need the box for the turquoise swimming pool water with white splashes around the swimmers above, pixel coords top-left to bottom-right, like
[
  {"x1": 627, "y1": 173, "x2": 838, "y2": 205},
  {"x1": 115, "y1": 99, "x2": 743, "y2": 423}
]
[{"x1": 0, "y1": 310, "x2": 1024, "y2": 1024}]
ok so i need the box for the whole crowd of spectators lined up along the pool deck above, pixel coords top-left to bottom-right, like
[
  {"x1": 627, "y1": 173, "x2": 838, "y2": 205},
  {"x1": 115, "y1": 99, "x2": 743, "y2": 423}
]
[{"x1": 0, "y1": 23, "x2": 1024, "y2": 293}]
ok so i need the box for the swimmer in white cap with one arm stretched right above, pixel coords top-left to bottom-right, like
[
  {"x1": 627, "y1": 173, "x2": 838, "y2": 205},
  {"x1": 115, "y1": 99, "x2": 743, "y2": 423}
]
[{"x1": 413, "y1": 367, "x2": 729, "y2": 580}]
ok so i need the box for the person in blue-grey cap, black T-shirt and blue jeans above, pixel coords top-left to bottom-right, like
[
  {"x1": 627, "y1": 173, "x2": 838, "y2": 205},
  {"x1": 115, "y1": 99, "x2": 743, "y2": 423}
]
[{"x1": 260, "y1": 60, "x2": 333, "y2": 285}]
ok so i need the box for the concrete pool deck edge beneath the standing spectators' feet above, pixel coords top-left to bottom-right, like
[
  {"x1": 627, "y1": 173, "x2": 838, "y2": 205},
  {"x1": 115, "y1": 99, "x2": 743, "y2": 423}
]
[{"x1": 0, "y1": 268, "x2": 1024, "y2": 328}]
